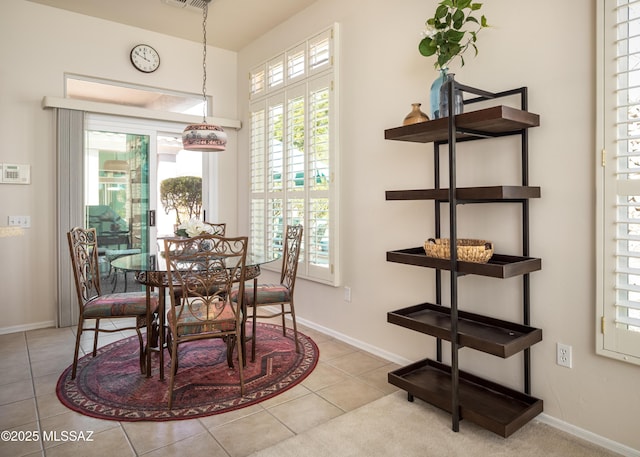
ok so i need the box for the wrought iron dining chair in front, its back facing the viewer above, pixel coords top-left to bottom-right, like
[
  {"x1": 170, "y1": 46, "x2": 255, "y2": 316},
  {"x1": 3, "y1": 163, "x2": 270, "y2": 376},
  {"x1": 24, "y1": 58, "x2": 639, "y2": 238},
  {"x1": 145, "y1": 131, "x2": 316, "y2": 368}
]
[{"x1": 164, "y1": 234, "x2": 248, "y2": 409}]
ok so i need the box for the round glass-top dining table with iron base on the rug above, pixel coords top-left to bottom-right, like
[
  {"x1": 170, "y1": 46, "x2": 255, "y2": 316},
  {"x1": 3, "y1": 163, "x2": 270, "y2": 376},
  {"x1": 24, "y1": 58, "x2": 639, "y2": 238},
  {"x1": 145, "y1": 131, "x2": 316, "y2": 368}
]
[{"x1": 111, "y1": 252, "x2": 280, "y2": 379}]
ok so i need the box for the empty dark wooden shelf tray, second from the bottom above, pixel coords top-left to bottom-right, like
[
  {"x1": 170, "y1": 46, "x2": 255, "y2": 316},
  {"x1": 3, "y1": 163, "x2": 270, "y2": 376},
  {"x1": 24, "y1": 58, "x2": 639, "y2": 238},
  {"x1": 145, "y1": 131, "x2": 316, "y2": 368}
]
[{"x1": 387, "y1": 303, "x2": 542, "y2": 358}]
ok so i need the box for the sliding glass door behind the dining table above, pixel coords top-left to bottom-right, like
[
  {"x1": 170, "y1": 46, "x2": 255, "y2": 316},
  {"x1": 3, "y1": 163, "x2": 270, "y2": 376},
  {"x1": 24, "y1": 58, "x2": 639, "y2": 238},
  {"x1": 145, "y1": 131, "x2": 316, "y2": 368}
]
[{"x1": 82, "y1": 115, "x2": 204, "y2": 291}]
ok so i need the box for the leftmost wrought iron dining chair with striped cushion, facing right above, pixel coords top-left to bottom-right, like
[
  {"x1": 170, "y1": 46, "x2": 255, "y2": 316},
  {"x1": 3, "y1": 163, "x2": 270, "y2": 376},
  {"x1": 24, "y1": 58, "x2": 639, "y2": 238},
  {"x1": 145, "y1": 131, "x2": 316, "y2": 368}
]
[{"x1": 67, "y1": 227, "x2": 158, "y2": 379}]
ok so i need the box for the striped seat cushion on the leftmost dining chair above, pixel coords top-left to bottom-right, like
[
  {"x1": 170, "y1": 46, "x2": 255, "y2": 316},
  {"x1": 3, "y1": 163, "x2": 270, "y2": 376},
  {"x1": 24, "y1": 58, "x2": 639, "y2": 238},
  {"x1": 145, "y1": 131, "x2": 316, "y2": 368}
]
[{"x1": 82, "y1": 292, "x2": 158, "y2": 319}]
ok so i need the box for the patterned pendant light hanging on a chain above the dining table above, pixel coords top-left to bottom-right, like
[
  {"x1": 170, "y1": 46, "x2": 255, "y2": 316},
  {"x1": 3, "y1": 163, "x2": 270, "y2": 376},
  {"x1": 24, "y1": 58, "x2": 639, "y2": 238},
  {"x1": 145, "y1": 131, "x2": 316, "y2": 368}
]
[{"x1": 182, "y1": 0, "x2": 227, "y2": 152}]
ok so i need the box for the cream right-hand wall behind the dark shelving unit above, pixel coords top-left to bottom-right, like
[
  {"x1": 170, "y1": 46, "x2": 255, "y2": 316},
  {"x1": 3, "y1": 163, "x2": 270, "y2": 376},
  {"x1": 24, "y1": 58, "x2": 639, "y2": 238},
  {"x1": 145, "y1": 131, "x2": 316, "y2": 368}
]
[{"x1": 238, "y1": 0, "x2": 640, "y2": 449}]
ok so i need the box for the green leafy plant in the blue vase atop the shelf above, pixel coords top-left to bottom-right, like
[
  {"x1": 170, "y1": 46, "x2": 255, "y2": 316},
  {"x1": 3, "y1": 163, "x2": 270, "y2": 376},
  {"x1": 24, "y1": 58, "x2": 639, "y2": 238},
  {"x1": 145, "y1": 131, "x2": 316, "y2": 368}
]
[{"x1": 418, "y1": 0, "x2": 488, "y2": 70}]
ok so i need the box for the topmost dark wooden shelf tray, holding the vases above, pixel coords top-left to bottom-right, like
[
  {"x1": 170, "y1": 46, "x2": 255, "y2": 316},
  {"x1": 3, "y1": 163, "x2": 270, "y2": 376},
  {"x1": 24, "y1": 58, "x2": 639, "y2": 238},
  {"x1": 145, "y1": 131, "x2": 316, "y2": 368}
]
[{"x1": 384, "y1": 105, "x2": 540, "y2": 143}]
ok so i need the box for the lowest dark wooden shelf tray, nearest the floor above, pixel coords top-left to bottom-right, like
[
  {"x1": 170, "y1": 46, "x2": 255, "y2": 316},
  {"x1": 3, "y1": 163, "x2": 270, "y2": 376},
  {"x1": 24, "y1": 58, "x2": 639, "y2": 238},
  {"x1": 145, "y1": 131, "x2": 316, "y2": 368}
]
[{"x1": 388, "y1": 359, "x2": 543, "y2": 438}]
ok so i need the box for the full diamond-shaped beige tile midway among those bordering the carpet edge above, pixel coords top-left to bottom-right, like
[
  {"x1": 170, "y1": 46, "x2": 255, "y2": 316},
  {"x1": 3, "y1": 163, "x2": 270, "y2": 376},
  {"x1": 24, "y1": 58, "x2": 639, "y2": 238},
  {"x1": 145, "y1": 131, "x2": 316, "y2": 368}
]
[{"x1": 268, "y1": 394, "x2": 344, "y2": 433}]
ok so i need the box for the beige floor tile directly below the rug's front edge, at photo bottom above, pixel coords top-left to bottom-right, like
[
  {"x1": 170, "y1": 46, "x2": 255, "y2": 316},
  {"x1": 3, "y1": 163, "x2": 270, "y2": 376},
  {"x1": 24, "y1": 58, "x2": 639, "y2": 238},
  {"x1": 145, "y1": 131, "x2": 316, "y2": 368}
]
[{"x1": 122, "y1": 419, "x2": 206, "y2": 454}]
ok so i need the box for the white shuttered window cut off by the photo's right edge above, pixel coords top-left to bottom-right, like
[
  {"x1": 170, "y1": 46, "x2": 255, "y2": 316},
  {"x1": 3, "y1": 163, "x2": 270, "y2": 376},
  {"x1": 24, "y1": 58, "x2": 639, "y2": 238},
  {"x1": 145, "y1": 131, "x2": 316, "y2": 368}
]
[{"x1": 596, "y1": 0, "x2": 640, "y2": 364}]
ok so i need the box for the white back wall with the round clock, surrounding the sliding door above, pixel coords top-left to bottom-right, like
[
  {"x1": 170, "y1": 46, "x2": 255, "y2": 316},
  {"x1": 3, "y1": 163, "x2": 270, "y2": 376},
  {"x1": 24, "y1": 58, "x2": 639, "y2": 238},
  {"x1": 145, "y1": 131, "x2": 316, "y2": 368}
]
[{"x1": 0, "y1": 0, "x2": 237, "y2": 333}]
